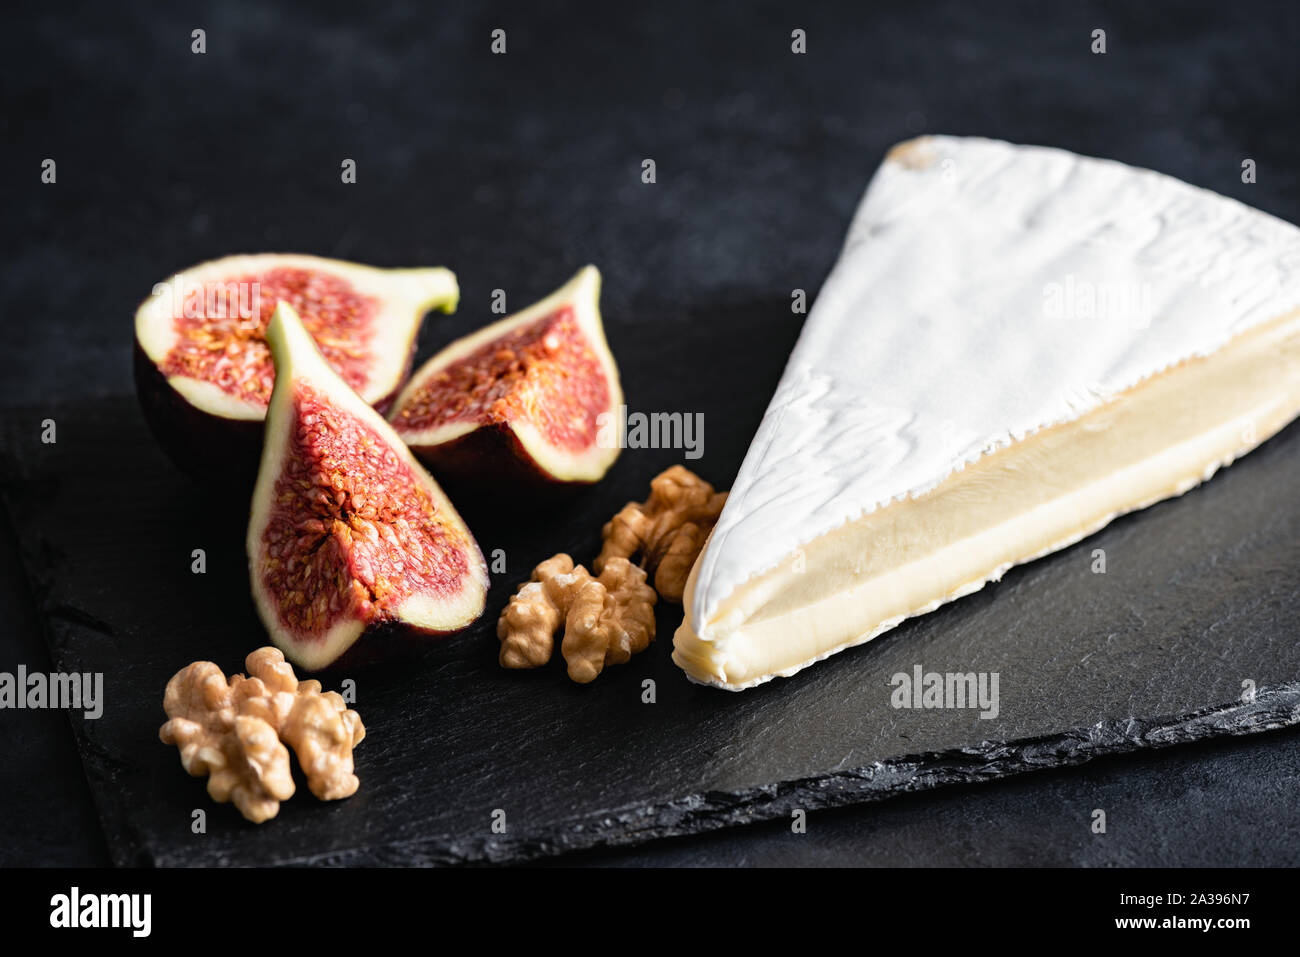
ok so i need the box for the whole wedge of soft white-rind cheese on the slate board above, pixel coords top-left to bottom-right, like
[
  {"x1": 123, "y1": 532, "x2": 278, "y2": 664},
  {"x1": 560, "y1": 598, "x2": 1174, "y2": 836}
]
[{"x1": 673, "y1": 137, "x2": 1300, "y2": 689}]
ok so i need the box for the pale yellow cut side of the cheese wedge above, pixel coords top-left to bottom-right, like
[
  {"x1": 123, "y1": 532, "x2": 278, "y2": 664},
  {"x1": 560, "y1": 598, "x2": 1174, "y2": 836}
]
[{"x1": 673, "y1": 312, "x2": 1300, "y2": 690}]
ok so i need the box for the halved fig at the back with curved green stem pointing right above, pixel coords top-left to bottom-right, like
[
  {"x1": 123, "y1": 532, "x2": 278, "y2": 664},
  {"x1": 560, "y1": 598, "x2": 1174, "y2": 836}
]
[{"x1": 135, "y1": 254, "x2": 459, "y2": 485}]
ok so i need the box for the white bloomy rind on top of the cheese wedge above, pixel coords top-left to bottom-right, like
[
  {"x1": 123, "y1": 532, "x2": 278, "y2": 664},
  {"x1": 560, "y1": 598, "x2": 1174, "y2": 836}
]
[{"x1": 688, "y1": 137, "x2": 1300, "y2": 686}]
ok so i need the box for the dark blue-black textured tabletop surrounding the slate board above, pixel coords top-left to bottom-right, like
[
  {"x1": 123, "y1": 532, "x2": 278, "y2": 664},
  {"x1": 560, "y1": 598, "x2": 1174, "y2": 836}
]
[{"x1": 0, "y1": 4, "x2": 1300, "y2": 863}]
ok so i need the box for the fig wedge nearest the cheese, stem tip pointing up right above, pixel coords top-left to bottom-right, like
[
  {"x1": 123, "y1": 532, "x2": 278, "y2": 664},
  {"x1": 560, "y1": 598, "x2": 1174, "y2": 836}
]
[{"x1": 389, "y1": 265, "x2": 623, "y2": 484}]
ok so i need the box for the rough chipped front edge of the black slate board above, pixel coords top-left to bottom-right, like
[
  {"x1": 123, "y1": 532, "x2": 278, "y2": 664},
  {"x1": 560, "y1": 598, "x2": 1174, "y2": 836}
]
[{"x1": 159, "y1": 681, "x2": 1300, "y2": 867}]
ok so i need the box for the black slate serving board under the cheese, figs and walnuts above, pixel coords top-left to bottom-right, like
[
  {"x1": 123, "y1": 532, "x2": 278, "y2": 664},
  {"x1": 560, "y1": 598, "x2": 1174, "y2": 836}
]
[{"x1": 0, "y1": 330, "x2": 1300, "y2": 865}]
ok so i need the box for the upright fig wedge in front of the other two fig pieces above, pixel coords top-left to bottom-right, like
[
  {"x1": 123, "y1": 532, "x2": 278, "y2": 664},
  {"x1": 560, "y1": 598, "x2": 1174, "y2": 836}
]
[{"x1": 247, "y1": 303, "x2": 488, "y2": 670}]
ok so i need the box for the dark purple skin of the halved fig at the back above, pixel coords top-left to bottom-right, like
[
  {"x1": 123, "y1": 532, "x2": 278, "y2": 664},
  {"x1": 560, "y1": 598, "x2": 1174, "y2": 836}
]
[{"x1": 134, "y1": 339, "x2": 415, "y2": 489}]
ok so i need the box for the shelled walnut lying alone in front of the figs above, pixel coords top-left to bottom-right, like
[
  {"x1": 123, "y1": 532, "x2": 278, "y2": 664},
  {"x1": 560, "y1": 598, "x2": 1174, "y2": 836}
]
[{"x1": 159, "y1": 648, "x2": 365, "y2": 823}]
